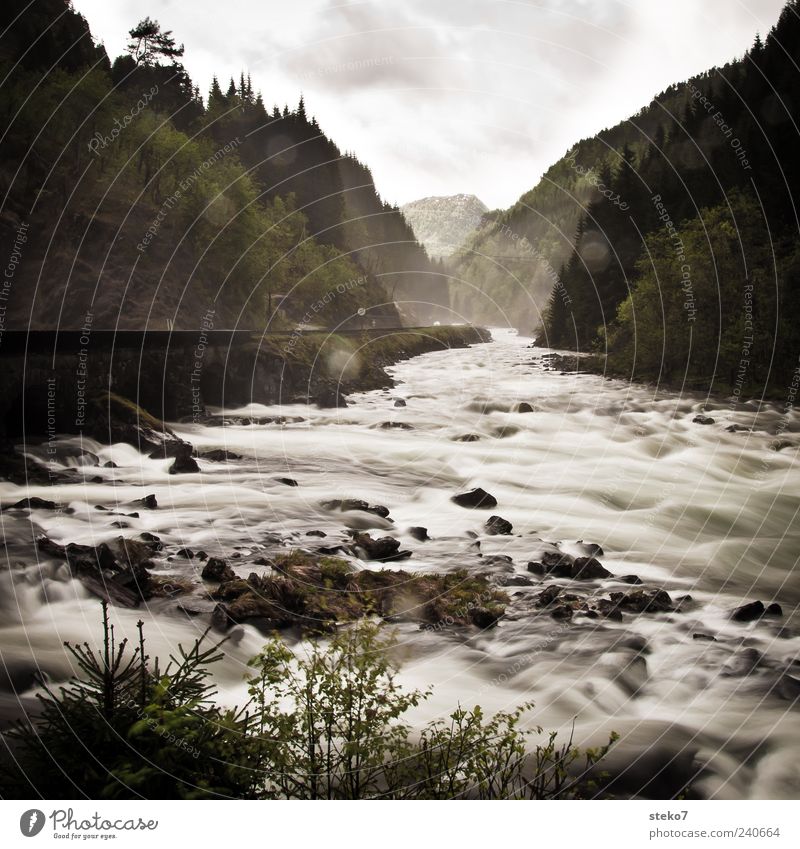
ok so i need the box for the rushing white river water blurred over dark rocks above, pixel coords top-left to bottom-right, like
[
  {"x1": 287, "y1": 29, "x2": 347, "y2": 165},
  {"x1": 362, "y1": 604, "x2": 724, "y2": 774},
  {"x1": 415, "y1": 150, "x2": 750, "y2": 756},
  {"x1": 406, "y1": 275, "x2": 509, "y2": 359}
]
[{"x1": 0, "y1": 331, "x2": 800, "y2": 798}]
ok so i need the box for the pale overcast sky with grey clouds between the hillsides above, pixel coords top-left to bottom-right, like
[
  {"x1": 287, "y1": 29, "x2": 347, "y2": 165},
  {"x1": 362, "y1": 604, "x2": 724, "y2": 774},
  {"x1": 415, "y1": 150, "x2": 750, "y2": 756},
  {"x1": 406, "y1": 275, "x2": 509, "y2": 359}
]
[{"x1": 74, "y1": 0, "x2": 783, "y2": 207}]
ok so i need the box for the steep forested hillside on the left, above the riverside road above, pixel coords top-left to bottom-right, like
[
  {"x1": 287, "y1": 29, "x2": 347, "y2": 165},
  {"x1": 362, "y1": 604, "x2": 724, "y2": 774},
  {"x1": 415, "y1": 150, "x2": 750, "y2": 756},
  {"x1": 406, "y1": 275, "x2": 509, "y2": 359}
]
[{"x1": 0, "y1": 0, "x2": 447, "y2": 329}]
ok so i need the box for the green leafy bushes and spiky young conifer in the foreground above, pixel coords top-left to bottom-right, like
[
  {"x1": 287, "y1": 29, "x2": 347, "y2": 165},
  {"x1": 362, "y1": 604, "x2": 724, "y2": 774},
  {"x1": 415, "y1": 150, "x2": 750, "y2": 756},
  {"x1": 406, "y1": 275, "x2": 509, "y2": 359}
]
[{"x1": 2, "y1": 604, "x2": 616, "y2": 799}]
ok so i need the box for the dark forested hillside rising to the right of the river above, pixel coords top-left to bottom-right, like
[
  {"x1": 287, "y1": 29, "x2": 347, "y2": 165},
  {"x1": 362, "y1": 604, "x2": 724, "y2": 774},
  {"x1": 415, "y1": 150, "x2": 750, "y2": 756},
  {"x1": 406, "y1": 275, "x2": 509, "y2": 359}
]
[{"x1": 454, "y1": 0, "x2": 800, "y2": 394}]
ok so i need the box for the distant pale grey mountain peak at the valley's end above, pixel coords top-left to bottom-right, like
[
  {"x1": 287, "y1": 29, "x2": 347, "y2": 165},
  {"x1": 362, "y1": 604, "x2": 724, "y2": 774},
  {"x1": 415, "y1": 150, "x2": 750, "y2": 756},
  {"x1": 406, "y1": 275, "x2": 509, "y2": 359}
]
[{"x1": 401, "y1": 193, "x2": 489, "y2": 259}]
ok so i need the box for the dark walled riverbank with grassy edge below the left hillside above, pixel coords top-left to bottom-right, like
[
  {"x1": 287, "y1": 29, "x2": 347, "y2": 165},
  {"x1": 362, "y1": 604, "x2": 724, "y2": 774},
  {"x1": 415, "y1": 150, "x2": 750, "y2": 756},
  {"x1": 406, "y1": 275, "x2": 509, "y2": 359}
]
[{"x1": 0, "y1": 325, "x2": 491, "y2": 483}]
